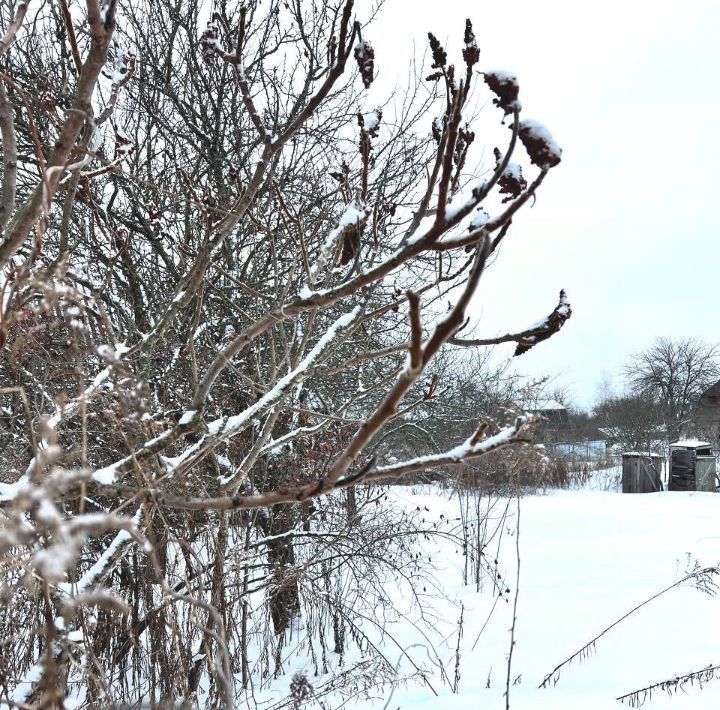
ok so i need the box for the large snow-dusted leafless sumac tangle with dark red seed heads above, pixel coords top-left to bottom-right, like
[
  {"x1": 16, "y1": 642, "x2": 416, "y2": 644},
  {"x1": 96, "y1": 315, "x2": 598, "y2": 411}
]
[{"x1": 0, "y1": 0, "x2": 570, "y2": 707}]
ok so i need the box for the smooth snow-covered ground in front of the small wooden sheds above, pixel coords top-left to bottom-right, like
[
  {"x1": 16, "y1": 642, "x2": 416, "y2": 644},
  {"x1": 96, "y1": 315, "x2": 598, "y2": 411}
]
[{"x1": 254, "y1": 472, "x2": 720, "y2": 710}]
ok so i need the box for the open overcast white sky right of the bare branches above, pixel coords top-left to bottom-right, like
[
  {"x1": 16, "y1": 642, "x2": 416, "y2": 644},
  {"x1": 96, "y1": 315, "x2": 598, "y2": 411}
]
[{"x1": 358, "y1": 0, "x2": 720, "y2": 406}]
